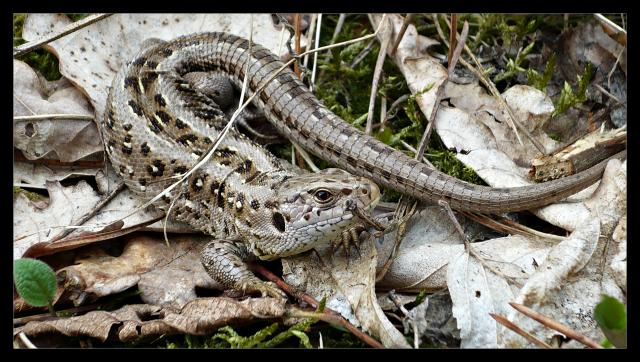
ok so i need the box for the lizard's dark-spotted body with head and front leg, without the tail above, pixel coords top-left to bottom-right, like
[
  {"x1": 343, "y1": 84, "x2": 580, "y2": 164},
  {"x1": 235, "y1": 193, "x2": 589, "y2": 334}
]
[{"x1": 101, "y1": 35, "x2": 380, "y2": 297}]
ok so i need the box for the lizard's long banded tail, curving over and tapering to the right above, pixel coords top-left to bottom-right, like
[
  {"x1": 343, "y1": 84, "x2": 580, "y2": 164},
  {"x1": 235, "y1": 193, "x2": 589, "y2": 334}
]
[{"x1": 114, "y1": 33, "x2": 620, "y2": 213}]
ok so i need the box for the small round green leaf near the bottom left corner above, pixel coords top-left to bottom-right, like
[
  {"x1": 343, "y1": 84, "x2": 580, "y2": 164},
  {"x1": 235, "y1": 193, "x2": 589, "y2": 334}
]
[{"x1": 13, "y1": 259, "x2": 57, "y2": 307}]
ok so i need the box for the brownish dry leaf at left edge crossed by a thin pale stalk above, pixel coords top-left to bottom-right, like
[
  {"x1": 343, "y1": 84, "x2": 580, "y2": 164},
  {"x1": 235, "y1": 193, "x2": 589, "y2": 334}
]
[{"x1": 13, "y1": 60, "x2": 102, "y2": 162}]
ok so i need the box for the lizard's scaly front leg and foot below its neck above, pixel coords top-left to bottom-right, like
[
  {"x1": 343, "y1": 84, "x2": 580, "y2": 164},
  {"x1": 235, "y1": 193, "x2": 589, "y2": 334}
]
[{"x1": 200, "y1": 239, "x2": 286, "y2": 298}]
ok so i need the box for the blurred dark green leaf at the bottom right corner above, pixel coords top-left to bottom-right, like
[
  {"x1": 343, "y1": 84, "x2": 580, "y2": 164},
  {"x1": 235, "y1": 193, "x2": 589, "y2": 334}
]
[{"x1": 593, "y1": 295, "x2": 627, "y2": 348}]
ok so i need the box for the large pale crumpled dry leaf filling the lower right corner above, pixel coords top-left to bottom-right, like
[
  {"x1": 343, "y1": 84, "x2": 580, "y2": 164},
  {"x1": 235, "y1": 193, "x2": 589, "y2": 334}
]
[{"x1": 500, "y1": 161, "x2": 626, "y2": 348}]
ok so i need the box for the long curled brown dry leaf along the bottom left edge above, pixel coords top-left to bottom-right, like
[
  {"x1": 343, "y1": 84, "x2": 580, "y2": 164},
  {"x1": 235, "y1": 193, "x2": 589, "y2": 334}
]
[{"x1": 14, "y1": 297, "x2": 286, "y2": 342}]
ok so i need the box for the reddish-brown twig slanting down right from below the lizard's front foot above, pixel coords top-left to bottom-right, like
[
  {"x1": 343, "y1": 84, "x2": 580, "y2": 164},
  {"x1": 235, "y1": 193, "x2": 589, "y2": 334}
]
[{"x1": 252, "y1": 264, "x2": 384, "y2": 348}]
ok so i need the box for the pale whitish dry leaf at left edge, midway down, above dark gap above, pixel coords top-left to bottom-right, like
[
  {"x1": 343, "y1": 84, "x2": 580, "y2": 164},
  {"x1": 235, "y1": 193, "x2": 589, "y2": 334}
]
[{"x1": 13, "y1": 181, "x2": 100, "y2": 259}]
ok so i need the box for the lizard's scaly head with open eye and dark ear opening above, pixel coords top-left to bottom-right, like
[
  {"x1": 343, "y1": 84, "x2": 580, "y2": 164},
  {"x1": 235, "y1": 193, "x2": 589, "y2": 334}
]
[{"x1": 249, "y1": 169, "x2": 380, "y2": 259}]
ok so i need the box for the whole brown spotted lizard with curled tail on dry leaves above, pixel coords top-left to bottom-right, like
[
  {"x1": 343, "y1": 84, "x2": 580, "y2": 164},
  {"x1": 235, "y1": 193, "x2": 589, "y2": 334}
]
[{"x1": 102, "y1": 33, "x2": 624, "y2": 296}]
